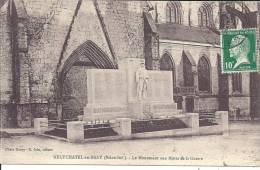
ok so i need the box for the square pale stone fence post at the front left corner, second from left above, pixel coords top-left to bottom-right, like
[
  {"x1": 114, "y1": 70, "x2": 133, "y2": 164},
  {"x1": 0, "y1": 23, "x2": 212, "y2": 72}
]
[{"x1": 67, "y1": 121, "x2": 84, "y2": 142}]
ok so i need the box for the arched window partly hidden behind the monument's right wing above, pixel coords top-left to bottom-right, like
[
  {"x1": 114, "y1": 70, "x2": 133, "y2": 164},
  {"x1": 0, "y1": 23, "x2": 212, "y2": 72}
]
[{"x1": 160, "y1": 53, "x2": 175, "y2": 86}]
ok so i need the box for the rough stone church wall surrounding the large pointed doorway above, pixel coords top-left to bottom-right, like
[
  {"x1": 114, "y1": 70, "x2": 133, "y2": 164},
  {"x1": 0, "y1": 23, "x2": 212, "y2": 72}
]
[{"x1": 0, "y1": 0, "x2": 149, "y2": 126}]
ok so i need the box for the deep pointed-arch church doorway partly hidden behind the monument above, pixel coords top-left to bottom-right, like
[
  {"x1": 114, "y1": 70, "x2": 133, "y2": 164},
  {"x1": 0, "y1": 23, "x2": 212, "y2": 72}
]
[{"x1": 57, "y1": 41, "x2": 117, "y2": 120}]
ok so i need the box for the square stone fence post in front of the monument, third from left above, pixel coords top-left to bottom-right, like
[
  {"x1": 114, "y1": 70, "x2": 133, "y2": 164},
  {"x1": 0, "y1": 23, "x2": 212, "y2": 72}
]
[{"x1": 113, "y1": 118, "x2": 132, "y2": 139}]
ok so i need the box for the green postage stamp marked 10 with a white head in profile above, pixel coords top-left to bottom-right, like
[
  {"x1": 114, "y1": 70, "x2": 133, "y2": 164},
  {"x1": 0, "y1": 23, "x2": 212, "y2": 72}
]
[{"x1": 221, "y1": 29, "x2": 258, "y2": 73}]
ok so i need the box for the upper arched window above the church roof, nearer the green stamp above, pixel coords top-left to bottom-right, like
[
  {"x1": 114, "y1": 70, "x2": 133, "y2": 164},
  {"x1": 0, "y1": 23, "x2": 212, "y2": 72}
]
[{"x1": 198, "y1": 2, "x2": 213, "y2": 27}]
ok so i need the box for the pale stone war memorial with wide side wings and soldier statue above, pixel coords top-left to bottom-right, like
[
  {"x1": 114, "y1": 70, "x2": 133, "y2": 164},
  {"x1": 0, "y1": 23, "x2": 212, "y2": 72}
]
[{"x1": 83, "y1": 58, "x2": 179, "y2": 120}]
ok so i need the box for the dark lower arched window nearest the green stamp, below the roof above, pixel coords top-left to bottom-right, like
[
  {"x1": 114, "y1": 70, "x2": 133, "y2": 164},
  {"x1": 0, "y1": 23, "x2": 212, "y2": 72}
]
[{"x1": 198, "y1": 56, "x2": 210, "y2": 92}]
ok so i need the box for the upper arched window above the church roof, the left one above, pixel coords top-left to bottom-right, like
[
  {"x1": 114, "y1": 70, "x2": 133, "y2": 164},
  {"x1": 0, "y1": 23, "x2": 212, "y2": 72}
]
[{"x1": 166, "y1": 1, "x2": 182, "y2": 24}]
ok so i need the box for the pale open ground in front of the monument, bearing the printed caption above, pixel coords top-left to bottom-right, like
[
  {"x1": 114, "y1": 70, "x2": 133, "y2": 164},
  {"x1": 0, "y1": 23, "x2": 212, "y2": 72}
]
[{"x1": 2, "y1": 121, "x2": 260, "y2": 166}]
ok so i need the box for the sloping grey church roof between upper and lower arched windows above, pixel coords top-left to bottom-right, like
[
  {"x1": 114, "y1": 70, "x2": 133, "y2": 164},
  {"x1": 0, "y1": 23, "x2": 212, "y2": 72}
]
[{"x1": 156, "y1": 23, "x2": 220, "y2": 44}]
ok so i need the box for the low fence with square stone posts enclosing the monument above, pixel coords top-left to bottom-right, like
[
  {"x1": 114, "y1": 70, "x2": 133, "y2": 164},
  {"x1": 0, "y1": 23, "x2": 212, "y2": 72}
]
[{"x1": 34, "y1": 111, "x2": 228, "y2": 142}]
